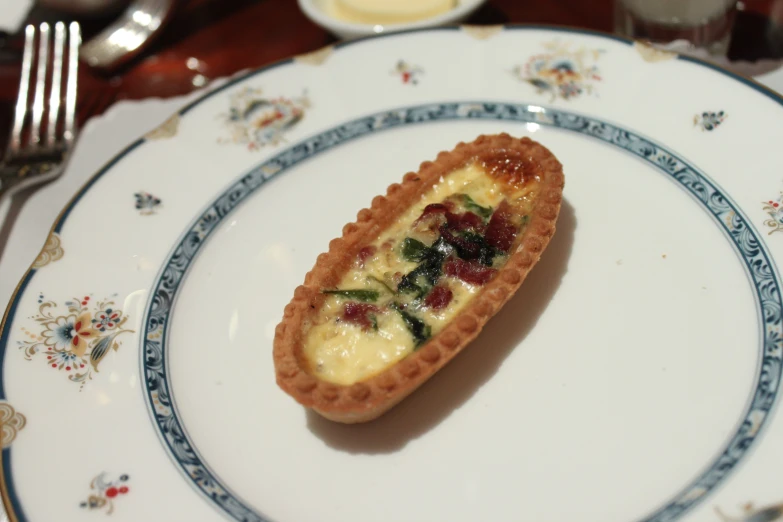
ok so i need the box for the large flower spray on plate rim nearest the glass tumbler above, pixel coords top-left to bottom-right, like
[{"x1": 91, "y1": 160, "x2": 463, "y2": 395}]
[{"x1": 512, "y1": 42, "x2": 603, "y2": 101}]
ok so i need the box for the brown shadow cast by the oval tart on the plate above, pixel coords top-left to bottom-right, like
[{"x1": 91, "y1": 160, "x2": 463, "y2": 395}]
[{"x1": 306, "y1": 199, "x2": 576, "y2": 454}]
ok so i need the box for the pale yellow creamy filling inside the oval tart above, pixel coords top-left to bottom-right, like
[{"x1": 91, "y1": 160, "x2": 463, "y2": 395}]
[{"x1": 303, "y1": 164, "x2": 536, "y2": 385}]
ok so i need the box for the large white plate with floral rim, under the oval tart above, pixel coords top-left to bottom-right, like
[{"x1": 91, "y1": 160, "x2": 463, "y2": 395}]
[{"x1": 0, "y1": 27, "x2": 783, "y2": 522}]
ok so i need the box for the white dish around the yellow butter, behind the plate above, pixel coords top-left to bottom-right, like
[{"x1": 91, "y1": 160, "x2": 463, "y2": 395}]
[{"x1": 298, "y1": 0, "x2": 486, "y2": 40}]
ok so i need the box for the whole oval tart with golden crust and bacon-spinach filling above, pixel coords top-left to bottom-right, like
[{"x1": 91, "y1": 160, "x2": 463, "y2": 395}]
[{"x1": 274, "y1": 134, "x2": 565, "y2": 423}]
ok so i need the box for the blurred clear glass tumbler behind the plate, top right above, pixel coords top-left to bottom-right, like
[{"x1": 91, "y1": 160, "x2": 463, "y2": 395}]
[{"x1": 614, "y1": 0, "x2": 737, "y2": 55}]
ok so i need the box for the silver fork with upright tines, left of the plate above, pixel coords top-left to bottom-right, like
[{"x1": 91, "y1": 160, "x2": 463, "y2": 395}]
[{"x1": 0, "y1": 22, "x2": 81, "y2": 202}]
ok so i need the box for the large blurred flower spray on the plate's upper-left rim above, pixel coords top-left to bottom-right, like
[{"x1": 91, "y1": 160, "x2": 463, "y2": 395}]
[{"x1": 218, "y1": 87, "x2": 310, "y2": 150}]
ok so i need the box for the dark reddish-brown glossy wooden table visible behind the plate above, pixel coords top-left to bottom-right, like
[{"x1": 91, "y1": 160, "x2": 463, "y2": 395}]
[{"x1": 0, "y1": 0, "x2": 783, "y2": 143}]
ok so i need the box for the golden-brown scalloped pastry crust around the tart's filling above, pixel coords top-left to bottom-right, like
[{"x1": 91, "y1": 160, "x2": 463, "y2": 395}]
[{"x1": 274, "y1": 134, "x2": 565, "y2": 424}]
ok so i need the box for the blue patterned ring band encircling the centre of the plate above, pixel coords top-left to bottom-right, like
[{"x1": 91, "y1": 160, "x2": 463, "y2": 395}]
[{"x1": 142, "y1": 101, "x2": 783, "y2": 522}]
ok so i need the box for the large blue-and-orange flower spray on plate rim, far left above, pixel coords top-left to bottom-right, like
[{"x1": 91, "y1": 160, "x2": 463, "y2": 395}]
[{"x1": 18, "y1": 296, "x2": 132, "y2": 389}]
